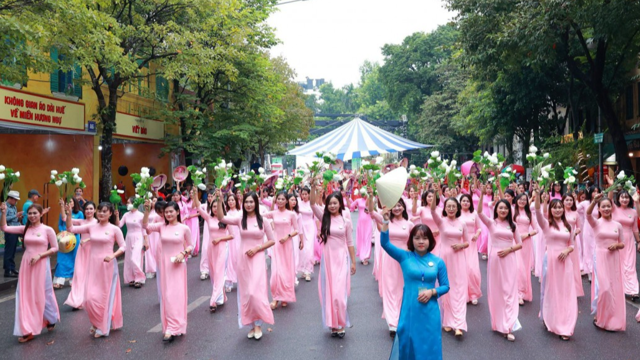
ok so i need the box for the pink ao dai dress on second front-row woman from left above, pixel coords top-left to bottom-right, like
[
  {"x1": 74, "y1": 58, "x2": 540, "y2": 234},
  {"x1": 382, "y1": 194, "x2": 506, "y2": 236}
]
[{"x1": 69, "y1": 223, "x2": 126, "y2": 336}]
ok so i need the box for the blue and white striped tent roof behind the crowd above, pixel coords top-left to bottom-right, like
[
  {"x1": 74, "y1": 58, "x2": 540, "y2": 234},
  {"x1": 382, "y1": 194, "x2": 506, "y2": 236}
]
[{"x1": 287, "y1": 118, "x2": 433, "y2": 161}]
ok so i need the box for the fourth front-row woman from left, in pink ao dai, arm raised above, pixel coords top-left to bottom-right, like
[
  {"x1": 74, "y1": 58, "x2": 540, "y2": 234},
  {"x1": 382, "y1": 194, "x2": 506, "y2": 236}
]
[{"x1": 216, "y1": 189, "x2": 275, "y2": 340}]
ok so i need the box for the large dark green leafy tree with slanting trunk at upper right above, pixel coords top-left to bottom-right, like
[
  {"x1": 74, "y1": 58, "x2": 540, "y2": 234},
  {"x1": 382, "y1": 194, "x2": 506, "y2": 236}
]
[{"x1": 447, "y1": 0, "x2": 640, "y2": 170}]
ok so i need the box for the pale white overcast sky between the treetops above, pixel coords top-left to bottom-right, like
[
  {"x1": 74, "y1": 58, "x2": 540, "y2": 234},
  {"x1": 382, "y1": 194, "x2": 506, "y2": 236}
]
[{"x1": 268, "y1": 0, "x2": 454, "y2": 87}]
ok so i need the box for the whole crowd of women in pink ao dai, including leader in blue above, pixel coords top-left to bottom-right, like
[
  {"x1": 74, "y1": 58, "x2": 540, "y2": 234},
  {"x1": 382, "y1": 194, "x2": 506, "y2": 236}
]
[{"x1": 0, "y1": 169, "x2": 640, "y2": 359}]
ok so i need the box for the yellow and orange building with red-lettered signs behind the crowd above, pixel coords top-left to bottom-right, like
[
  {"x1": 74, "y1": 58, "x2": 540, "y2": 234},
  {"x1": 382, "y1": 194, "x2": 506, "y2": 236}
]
[{"x1": 0, "y1": 57, "x2": 172, "y2": 229}]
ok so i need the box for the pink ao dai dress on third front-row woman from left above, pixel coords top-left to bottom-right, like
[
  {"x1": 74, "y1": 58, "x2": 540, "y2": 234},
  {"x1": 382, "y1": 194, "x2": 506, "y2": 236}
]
[{"x1": 145, "y1": 222, "x2": 192, "y2": 336}]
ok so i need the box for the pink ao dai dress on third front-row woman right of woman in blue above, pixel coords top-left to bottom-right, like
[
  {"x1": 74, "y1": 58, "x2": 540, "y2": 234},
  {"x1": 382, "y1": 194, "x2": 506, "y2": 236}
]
[{"x1": 536, "y1": 209, "x2": 578, "y2": 336}]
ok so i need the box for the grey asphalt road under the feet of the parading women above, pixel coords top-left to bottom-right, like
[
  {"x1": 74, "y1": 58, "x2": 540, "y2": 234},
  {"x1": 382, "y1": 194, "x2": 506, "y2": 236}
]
[{"x1": 0, "y1": 214, "x2": 640, "y2": 360}]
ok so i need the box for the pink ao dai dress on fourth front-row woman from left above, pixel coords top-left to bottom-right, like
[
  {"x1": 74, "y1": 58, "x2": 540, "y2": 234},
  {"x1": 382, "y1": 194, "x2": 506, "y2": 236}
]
[{"x1": 222, "y1": 215, "x2": 276, "y2": 328}]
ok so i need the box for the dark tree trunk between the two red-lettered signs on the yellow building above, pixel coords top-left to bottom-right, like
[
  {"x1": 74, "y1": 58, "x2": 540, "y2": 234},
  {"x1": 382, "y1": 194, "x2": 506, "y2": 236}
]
[{"x1": 98, "y1": 86, "x2": 118, "y2": 201}]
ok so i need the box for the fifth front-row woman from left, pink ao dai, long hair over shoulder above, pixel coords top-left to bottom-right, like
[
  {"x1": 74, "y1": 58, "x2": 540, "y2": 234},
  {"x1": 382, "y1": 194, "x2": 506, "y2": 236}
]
[{"x1": 311, "y1": 183, "x2": 356, "y2": 338}]
